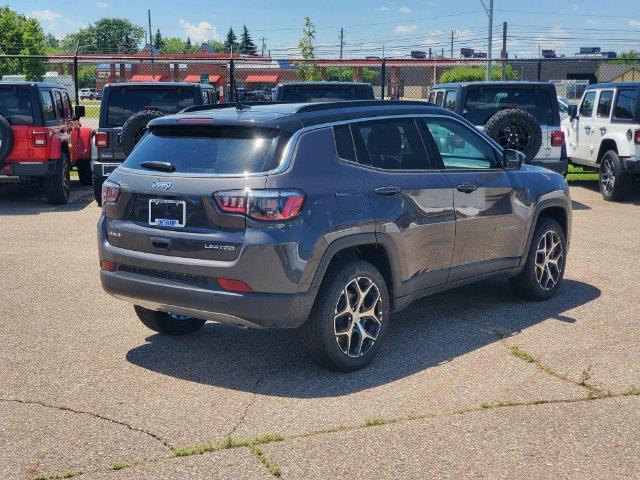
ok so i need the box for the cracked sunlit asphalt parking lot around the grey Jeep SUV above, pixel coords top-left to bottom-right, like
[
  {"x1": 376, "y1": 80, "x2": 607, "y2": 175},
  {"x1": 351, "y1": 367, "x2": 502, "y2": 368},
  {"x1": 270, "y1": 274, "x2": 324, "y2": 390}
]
[{"x1": 0, "y1": 183, "x2": 640, "y2": 480}]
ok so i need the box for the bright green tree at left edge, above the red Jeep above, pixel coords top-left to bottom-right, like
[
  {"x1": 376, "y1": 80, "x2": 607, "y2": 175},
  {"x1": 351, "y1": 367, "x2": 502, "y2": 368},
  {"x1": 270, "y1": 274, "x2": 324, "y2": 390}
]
[{"x1": 0, "y1": 7, "x2": 46, "y2": 80}]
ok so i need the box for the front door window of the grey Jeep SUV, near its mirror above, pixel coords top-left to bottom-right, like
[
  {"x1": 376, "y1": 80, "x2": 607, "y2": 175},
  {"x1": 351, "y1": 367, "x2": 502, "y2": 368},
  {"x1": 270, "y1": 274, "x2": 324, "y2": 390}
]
[{"x1": 420, "y1": 117, "x2": 497, "y2": 169}]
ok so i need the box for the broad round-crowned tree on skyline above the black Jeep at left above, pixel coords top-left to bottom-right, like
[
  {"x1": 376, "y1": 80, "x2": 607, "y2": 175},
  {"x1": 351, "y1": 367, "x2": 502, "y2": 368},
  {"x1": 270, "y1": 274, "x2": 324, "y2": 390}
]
[{"x1": 60, "y1": 18, "x2": 144, "y2": 54}]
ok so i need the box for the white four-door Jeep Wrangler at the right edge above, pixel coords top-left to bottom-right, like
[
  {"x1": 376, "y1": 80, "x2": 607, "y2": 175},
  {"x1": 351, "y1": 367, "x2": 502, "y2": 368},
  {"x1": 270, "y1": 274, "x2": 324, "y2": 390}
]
[{"x1": 562, "y1": 83, "x2": 640, "y2": 201}]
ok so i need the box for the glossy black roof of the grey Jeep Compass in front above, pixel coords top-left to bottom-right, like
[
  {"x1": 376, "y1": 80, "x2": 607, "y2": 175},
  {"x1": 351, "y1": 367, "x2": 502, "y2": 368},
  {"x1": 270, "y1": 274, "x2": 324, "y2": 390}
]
[{"x1": 150, "y1": 100, "x2": 450, "y2": 132}]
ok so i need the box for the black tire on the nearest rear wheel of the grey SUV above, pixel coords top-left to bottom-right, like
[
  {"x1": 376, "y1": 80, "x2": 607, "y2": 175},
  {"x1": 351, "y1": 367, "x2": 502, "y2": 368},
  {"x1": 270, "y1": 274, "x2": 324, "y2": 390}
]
[{"x1": 302, "y1": 260, "x2": 389, "y2": 372}]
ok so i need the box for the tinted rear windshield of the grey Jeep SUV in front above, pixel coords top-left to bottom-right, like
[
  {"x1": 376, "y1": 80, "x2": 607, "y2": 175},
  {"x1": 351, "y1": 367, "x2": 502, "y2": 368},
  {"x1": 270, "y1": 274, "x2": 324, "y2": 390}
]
[{"x1": 123, "y1": 126, "x2": 289, "y2": 175}]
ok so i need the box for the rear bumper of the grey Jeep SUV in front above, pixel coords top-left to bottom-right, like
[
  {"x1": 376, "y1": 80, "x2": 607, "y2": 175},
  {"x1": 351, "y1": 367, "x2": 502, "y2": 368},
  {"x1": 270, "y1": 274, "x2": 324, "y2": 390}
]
[{"x1": 98, "y1": 217, "x2": 318, "y2": 328}]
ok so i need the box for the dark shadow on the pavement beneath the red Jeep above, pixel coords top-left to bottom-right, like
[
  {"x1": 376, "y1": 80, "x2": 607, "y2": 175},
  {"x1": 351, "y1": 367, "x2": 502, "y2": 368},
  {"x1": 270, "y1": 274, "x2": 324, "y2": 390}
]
[{"x1": 0, "y1": 179, "x2": 94, "y2": 216}]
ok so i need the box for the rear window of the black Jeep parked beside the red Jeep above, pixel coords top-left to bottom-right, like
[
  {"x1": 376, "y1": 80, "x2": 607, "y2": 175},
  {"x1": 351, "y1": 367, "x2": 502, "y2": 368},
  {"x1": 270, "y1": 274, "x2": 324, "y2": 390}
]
[{"x1": 107, "y1": 87, "x2": 195, "y2": 127}]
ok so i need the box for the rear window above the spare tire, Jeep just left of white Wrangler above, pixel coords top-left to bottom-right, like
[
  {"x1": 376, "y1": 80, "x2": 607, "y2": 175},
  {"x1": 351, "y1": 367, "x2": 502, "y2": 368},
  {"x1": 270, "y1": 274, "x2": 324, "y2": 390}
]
[{"x1": 464, "y1": 86, "x2": 558, "y2": 125}]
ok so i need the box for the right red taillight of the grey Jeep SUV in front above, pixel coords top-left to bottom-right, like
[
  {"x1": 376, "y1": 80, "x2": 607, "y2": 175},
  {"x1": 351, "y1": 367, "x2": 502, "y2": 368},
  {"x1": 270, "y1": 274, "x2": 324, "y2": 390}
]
[{"x1": 213, "y1": 189, "x2": 304, "y2": 222}]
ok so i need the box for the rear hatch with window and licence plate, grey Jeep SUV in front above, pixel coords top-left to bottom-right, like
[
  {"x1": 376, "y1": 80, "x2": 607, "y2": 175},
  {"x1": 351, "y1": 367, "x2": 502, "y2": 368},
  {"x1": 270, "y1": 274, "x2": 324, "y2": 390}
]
[{"x1": 104, "y1": 121, "x2": 289, "y2": 261}]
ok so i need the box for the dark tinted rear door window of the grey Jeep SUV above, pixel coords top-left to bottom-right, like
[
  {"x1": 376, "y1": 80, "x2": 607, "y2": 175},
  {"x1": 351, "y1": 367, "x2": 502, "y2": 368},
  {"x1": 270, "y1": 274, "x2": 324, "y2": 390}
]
[{"x1": 356, "y1": 119, "x2": 430, "y2": 170}]
